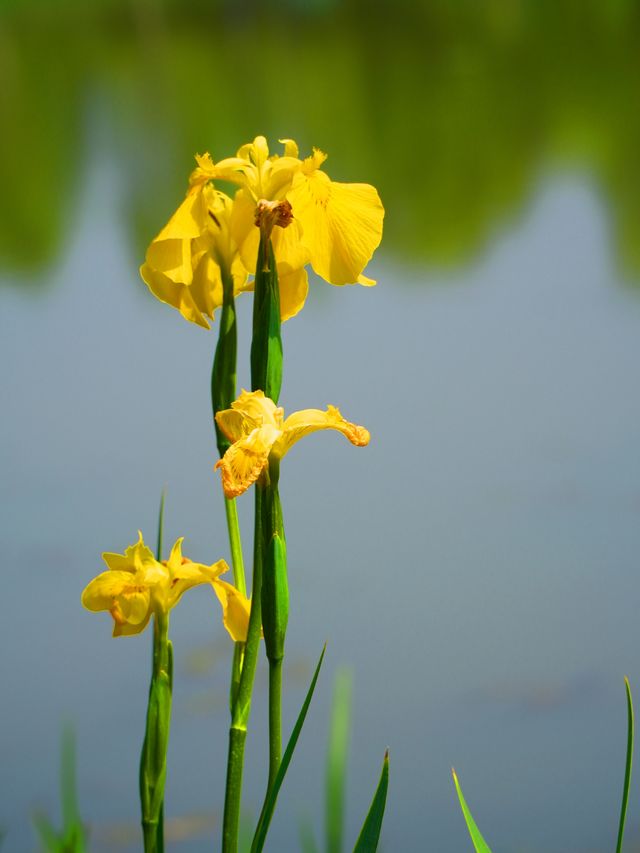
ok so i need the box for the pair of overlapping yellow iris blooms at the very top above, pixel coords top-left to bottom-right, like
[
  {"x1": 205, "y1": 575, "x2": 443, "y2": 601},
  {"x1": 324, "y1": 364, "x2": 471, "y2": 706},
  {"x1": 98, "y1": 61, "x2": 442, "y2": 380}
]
[{"x1": 140, "y1": 136, "x2": 384, "y2": 328}]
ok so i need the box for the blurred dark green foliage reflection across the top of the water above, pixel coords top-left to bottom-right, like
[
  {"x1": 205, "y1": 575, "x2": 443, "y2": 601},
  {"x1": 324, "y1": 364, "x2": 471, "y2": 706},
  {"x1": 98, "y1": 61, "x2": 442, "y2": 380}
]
[{"x1": 0, "y1": 0, "x2": 640, "y2": 277}]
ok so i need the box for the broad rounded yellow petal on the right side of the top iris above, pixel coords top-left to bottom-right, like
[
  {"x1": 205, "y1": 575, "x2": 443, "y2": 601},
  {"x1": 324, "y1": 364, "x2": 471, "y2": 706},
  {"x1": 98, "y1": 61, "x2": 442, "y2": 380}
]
[{"x1": 287, "y1": 170, "x2": 384, "y2": 284}]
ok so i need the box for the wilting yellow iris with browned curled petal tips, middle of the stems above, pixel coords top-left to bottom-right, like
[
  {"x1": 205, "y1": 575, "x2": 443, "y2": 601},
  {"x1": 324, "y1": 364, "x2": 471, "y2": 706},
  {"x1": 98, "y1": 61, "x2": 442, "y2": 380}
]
[{"x1": 215, "y1": 391, "x2": 370, "y2": 498}]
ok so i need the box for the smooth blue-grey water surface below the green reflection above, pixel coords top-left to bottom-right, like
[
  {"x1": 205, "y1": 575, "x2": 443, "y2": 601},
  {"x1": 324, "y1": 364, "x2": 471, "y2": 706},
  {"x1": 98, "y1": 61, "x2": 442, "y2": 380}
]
[{"x1": 0, "y1": 150, "x2": 640, "y2": 853}]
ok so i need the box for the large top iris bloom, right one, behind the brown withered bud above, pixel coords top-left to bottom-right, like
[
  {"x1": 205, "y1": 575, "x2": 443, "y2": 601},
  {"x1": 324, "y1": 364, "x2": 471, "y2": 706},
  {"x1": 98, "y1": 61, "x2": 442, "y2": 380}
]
[{"x1": 191, "y1": 136, "x2": 384, "y2": 320}]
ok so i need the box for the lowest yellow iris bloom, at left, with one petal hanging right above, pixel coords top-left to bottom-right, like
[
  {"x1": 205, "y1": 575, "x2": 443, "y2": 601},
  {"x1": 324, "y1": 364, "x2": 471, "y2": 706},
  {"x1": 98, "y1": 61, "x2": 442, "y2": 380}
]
[{"x1": 82, "y1": 532, "x2": 250, "y2": 641}]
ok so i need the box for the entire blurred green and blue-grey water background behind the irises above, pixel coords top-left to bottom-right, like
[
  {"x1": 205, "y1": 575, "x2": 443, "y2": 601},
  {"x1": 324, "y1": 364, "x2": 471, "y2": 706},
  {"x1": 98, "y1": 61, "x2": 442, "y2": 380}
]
[{"x1": 0, "y1": 0, "x2": 640, "y2": 853}]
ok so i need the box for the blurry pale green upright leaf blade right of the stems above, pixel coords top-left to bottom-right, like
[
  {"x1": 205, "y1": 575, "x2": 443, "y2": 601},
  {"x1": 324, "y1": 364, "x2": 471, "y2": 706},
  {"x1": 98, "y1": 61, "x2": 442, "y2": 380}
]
[{"x1": 326, "y1": 670, "x2": 351, "y2": 853}]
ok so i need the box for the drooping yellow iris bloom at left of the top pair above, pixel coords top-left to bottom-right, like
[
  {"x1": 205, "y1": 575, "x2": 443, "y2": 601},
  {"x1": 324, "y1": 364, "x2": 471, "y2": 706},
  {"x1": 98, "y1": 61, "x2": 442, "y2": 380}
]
[{"x1": 140, "y1": 184, "x2": 253, "y2": 329}]
